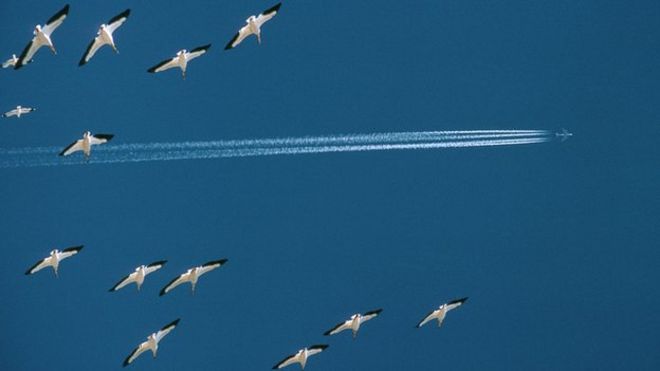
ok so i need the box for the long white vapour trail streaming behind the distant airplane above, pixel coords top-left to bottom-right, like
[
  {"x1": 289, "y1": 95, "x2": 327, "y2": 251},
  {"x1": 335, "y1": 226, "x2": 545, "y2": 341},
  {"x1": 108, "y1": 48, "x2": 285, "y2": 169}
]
[{"x1": 0, "y1": 130, "x2": 552, "y2": 168}]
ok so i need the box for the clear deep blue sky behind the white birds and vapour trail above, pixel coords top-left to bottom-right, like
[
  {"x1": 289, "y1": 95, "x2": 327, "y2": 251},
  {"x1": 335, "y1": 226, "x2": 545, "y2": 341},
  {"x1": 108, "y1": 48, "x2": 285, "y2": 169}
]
[{"x1": 0, "y1": 0, "x2": 660, "y2": 370}]
